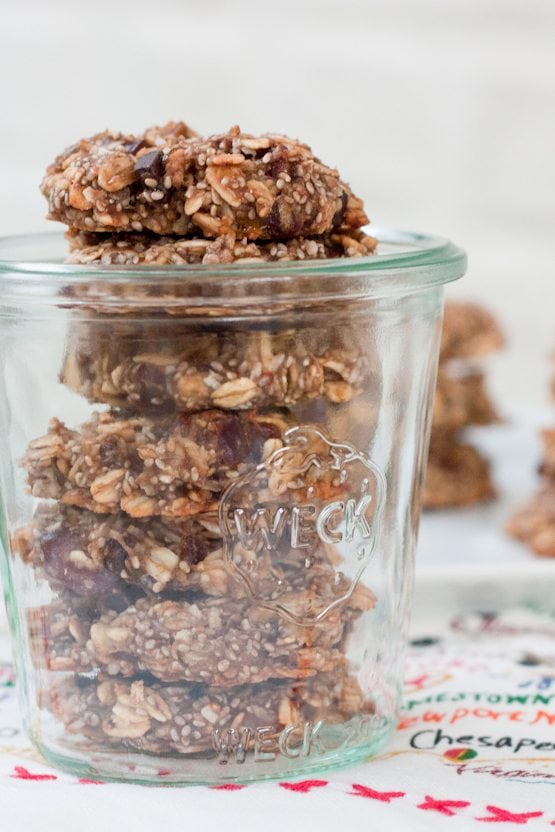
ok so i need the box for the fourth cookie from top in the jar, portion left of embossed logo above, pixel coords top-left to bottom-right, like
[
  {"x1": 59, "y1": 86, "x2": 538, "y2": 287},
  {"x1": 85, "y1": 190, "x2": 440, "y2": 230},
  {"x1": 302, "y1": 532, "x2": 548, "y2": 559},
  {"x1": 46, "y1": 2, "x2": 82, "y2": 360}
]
[{"x1": 22, "y1": 410, "x2": 288, "y2": 518}]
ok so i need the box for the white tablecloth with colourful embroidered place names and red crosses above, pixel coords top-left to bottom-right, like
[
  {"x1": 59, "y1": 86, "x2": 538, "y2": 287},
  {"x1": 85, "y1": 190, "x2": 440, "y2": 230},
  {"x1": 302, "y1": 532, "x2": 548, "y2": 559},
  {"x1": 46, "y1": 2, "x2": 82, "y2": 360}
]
[{"x1": 0, "y1": 607, "x2": 555, "y2": 832}]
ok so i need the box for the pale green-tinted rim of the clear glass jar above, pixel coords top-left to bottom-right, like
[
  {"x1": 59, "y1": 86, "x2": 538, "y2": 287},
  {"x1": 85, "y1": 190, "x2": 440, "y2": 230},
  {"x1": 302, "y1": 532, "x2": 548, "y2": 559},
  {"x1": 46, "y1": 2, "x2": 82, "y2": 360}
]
[{"x1": 0, "y1": 226, "x2": 466, "y2": 301}]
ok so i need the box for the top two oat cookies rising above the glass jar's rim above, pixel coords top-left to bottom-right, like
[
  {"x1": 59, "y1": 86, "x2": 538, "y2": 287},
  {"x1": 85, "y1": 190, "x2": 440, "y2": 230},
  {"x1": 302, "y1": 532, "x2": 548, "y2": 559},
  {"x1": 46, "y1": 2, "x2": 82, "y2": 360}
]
[{"x1": 42, "y1": 122, "x2": 376, "y2": 265}]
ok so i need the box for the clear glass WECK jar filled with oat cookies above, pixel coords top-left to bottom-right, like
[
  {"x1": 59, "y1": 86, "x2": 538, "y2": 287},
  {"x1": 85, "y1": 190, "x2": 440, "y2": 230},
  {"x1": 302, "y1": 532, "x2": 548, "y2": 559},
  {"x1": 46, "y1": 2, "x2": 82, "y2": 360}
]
[{"x1": 0, "y1": 230, "x2": 465, "y2": 783}]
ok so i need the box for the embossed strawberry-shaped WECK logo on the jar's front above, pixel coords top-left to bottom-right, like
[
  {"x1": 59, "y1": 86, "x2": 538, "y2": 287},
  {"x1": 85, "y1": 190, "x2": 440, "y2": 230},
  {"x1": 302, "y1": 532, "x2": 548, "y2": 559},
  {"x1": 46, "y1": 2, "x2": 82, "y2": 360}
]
[{"x1": 220, "y1": 426, "x2": 385, "y2": 625}]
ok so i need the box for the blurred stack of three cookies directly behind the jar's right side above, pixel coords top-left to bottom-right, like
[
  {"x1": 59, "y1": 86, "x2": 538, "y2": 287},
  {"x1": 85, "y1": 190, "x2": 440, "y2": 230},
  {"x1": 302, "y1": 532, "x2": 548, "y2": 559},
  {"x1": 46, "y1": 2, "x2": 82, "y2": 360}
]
[{"x1": 424, "y1": 302, "x2": 503, "y2": 509}]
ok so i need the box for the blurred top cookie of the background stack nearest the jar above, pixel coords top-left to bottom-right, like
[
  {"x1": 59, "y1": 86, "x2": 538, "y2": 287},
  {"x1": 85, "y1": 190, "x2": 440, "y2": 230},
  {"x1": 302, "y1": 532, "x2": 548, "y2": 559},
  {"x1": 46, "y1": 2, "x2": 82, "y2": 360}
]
[{"x1": 440, "y1": 302, "x2": 504, "y2": 361}]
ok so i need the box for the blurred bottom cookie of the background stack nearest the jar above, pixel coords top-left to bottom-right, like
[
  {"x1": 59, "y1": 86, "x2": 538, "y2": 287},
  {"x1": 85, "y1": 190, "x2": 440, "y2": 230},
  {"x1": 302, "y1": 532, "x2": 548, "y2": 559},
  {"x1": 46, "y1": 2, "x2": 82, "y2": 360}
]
[{"x1": 424, "y1": 434, "x2": 495, "y2": 508}]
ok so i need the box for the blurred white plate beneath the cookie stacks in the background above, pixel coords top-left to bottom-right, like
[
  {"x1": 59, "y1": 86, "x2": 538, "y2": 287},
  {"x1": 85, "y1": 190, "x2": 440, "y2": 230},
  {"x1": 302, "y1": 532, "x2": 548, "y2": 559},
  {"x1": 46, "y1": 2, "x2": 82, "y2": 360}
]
[{"x1": 413, "y1": 410, "x2": 555, "y2": 631}]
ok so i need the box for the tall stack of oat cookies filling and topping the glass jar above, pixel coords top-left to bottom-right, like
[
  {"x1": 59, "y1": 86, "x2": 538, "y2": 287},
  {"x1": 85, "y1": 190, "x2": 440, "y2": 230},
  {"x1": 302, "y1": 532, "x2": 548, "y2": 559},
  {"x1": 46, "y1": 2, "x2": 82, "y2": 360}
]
[{"x1": 16, "y1": 123, "x2": 382, "y2": 754}]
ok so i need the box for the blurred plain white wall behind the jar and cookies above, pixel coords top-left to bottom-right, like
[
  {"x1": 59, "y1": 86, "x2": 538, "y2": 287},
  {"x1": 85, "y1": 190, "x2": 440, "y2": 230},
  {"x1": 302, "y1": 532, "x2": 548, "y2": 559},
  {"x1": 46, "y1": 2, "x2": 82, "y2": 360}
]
[{"x1": 0, "y1": 0, "x2": 555, "y2": 407}]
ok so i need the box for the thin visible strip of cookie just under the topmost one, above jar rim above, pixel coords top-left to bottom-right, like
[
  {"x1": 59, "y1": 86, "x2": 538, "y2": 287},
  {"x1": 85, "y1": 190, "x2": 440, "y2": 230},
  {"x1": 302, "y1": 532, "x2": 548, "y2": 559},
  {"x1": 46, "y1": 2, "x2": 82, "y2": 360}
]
[{"x1": 66, "y1": 229, "x2": 378, "y2": 266}]
